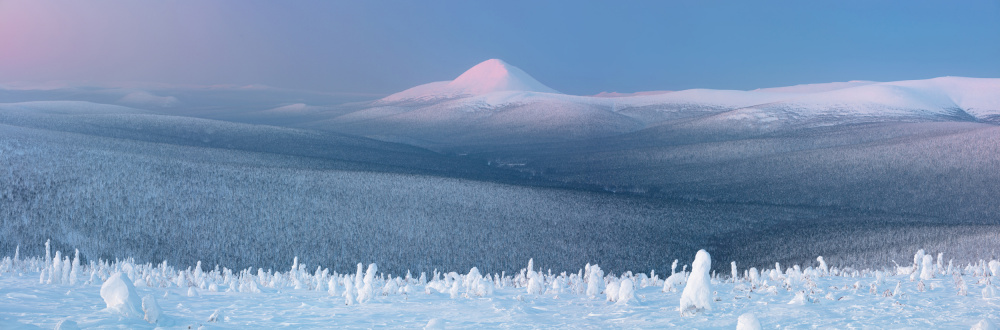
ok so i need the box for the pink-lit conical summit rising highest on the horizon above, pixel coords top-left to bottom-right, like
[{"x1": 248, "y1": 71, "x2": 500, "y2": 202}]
[{"x1": 382, "y1": 59, "x2": 559, "y2": 101}]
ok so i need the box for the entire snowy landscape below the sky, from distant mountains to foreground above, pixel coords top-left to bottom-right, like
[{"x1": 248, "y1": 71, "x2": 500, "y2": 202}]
[{"x1": 0, "y1": 59, "x2": 1000, "y2": 329}]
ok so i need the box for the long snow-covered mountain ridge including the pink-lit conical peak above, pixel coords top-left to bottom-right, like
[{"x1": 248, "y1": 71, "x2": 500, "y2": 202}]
[{"x1": 324, "y1": 59, "x2": 1000, "y2": 145}]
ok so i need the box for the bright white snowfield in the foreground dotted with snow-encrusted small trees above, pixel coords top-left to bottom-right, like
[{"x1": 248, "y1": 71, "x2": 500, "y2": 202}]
[{"x1": 0, "y1": 244, "x2": 1000, "y2": 329}]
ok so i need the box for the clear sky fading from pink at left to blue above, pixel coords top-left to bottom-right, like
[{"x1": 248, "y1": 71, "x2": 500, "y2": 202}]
[{"x1": 0, "y1": 0, "x2": 1000, "y2": 95}]
